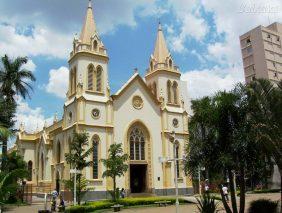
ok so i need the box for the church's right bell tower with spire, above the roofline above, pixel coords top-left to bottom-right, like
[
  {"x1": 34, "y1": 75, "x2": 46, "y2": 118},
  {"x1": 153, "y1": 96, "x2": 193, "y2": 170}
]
[{"x1": 145, "y1": 23, "x2": 181, "y2": 107}]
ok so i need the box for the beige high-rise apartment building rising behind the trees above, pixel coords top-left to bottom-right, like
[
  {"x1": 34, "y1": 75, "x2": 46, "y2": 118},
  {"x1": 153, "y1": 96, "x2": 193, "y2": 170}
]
[{"x1": 240, "y1": 22, "x2": 282, "y2": 83}]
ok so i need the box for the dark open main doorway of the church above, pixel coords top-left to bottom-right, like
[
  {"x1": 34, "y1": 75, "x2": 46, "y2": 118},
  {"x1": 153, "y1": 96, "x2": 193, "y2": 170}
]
[{"x1": 130, "y1": 164, "x2": 147, "y2": 193}]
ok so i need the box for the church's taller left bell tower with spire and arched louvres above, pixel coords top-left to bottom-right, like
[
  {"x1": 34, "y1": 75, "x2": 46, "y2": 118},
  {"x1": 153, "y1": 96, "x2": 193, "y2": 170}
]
[{"x1": 67, "y1": 0, "x2": 109, "y2": 100}]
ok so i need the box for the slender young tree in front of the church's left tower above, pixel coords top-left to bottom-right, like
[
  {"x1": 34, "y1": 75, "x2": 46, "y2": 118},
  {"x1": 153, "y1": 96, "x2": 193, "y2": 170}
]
[{"x1": 65, "y1": 132, "x2": 93, "y2": 205}]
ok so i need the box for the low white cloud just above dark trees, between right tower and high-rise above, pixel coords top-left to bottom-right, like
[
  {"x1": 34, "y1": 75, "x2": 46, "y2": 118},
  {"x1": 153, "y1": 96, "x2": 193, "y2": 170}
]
[{"x1": 181, "y1": 66, "x2": 244, "y2": 99}]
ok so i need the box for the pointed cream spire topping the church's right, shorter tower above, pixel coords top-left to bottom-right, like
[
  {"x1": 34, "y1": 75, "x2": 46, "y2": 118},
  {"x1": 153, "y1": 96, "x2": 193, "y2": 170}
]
[{"x1": 154, "y1": 22, "x2": 169, "y2": 63}]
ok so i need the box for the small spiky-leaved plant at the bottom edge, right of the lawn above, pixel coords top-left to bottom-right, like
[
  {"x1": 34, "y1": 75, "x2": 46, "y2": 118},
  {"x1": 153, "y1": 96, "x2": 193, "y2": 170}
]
[{"x1": 196, "y1": 193, "x2": 218, "y2": 213}]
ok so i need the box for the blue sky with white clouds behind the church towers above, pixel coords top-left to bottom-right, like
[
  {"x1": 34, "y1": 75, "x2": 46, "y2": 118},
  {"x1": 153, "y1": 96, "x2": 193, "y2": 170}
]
[{"x1": 0, "y1": 0, "x2": 282, "y2": 139}]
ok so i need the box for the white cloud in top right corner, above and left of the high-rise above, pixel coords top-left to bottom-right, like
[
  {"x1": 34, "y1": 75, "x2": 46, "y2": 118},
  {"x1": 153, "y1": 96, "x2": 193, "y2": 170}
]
[{"x1": 201, "y1": 0, "x2": 282, "y2": 64}]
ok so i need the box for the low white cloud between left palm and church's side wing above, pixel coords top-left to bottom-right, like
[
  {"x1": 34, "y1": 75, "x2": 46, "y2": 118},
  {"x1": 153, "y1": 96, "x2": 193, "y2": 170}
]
[{"x1": 15, "y1": 96, "x2": 53, "y2": 132}]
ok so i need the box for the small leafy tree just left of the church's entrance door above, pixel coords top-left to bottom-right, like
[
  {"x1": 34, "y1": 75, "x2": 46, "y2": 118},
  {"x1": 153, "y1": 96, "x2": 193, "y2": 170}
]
[{"x1": 101, "y1": 143, "x2": 128, "y2": 201}]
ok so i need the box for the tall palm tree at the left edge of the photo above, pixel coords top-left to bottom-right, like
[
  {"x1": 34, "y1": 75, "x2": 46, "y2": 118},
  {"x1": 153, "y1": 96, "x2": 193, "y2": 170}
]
[{"x1": 0, "y1": 55, "x2": 35, "y2": 156}]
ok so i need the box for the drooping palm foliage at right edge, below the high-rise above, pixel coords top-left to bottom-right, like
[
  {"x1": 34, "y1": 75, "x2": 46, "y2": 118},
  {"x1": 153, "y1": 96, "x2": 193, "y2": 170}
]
[{"x1": 248, "y1": 79, "x2": 282, "y2": 205}]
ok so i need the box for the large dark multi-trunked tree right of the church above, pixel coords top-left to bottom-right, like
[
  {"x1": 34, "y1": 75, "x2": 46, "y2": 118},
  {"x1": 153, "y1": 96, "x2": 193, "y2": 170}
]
[{"x1": 186, "y1": 84, "x2": 274, "y2": 213}]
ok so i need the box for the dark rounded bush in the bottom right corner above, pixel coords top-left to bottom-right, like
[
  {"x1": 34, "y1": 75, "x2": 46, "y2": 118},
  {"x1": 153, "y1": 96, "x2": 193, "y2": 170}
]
[{"x1": 249, "y1": 199, "x2": 278, "y2": 213}]
